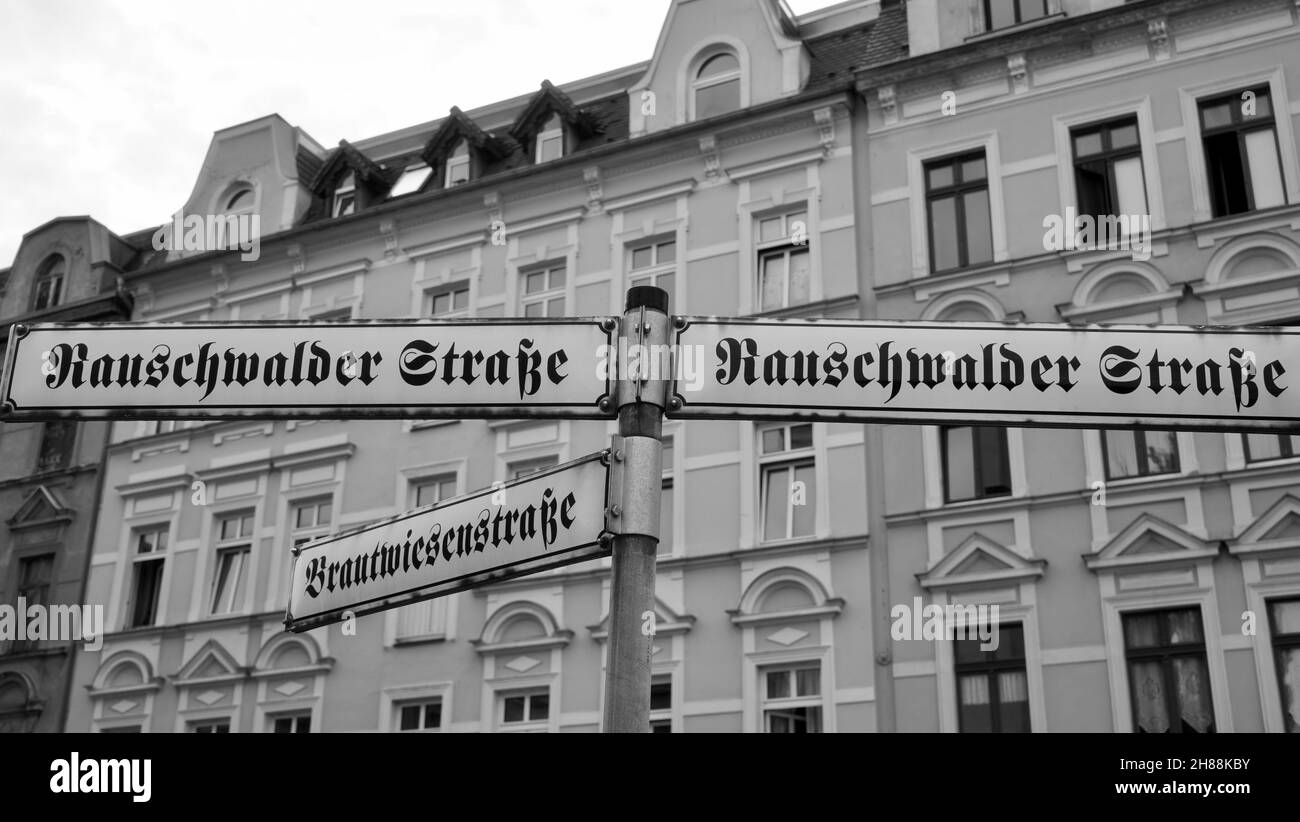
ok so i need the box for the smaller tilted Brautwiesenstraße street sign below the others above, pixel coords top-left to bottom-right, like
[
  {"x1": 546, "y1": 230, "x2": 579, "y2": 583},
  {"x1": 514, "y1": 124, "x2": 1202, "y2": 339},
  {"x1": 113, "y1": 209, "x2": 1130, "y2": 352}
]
[{"x1": 285, "y1": 451, "x2": 611, "y2": 631}]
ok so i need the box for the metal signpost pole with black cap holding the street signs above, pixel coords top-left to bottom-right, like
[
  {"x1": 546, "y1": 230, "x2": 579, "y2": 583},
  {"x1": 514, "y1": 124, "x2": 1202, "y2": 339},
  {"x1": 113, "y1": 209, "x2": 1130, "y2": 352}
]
[{"x1": 605, "y1": 286, "x2": 670, "y2": 734}]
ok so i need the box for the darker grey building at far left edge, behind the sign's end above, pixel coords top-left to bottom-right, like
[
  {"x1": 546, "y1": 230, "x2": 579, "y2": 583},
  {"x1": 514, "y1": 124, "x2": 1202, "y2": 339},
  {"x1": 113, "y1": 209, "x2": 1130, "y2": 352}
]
[{"x1": 0, "y1": 217, "x2": 138, "y2": 732}]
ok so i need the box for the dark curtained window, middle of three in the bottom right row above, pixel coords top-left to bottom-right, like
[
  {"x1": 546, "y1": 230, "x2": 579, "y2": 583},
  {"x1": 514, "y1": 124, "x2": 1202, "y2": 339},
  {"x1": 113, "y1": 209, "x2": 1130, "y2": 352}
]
[{"x1": 1123, "y1": 607, "x2": 1214, "y2": 734}]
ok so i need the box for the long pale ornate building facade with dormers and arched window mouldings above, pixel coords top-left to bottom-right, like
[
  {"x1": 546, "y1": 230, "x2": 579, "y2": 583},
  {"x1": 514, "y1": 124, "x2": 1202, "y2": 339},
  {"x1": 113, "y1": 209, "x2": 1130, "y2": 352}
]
[{"x1": 7, "y1": 0, "x2": 1300, "y2": 732}]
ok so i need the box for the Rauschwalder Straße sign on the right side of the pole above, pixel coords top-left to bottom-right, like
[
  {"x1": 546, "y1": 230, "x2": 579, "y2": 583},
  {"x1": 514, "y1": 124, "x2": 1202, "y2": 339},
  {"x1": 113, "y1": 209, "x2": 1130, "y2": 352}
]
[{"x1": 667, "y1": 317, "x2": 1300, "y2": 431}]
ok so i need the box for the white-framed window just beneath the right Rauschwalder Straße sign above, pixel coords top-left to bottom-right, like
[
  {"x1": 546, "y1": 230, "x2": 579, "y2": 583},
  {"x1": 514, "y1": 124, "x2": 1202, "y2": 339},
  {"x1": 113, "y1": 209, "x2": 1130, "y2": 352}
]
[{"x1": 758, "y1": 423, "x2": 816, "y2": 542}]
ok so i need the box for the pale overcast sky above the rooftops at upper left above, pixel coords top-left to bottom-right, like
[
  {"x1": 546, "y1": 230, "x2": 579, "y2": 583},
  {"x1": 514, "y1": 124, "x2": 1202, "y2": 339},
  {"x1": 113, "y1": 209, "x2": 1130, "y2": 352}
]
[{"x1": 0, "y1": 0, "x2": 833, "y2": 269}]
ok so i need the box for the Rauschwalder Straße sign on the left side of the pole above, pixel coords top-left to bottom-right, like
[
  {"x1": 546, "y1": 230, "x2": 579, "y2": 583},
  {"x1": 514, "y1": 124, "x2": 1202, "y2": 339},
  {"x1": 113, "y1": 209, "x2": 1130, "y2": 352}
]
[{"x1": 0, "y1": 317, "x2": 618, "y2": 419}]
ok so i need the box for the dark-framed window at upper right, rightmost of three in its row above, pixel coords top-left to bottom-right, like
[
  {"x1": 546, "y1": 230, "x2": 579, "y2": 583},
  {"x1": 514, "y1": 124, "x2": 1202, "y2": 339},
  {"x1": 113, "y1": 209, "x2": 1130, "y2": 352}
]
[{"x1": 1197, "y1": 86, "x2": 1287, "y2": 217}]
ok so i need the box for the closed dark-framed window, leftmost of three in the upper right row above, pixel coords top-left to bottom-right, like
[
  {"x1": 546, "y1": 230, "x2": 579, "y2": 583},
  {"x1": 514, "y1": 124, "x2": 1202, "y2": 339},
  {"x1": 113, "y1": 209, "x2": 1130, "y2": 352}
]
[{"x1": 924, "y1": 151, "x2": 993, "y2": 273}]
